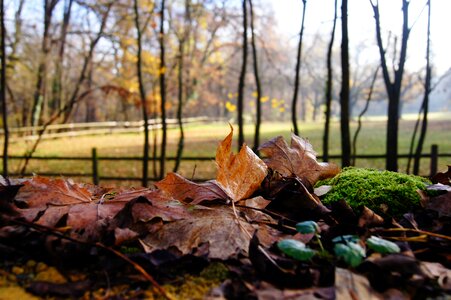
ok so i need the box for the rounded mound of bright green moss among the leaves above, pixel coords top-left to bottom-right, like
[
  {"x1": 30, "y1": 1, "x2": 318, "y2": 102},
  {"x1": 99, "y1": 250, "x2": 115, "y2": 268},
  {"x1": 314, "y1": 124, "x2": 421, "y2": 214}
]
[{"x1": 321, "y1": 167, "x2": 430, "y2": 216}]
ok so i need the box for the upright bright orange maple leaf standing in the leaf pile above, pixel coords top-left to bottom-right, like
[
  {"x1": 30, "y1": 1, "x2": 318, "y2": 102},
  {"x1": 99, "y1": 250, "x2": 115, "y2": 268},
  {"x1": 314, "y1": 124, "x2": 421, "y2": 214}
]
[{"x1": 216, "y1": 126, "x2": 268, "y2": 201}]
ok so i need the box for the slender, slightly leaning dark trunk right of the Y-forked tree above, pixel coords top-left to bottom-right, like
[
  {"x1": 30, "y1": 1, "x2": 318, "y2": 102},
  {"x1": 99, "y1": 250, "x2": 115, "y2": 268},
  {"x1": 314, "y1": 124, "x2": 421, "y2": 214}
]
[{"x1": 413, "y1": 0, "x2": 432, "y2": 175}]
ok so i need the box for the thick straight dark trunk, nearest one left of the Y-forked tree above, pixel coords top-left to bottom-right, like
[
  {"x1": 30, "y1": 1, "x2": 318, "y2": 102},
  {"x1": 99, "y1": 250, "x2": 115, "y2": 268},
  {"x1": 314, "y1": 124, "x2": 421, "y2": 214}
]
[{"x1": 340, "y1": 0, "x2": 351, "y2": 167}]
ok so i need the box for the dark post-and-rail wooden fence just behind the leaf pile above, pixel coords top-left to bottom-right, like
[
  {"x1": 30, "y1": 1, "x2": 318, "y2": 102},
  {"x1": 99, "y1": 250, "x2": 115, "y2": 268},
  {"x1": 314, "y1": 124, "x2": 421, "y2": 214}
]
[{"x1": 3, "y1": 145, "x2": 451, "y2": 184}]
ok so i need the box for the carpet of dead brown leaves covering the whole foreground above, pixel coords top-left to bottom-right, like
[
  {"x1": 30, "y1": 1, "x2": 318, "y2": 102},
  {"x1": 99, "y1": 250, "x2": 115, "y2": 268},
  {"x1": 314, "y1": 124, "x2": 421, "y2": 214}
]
[{"x1": 0, "y1": 128, "x2": 451, "y2": 299}]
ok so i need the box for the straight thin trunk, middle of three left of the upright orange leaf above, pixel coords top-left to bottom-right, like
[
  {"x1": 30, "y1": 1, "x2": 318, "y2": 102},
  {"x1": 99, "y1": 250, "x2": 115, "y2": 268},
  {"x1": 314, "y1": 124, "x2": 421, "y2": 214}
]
[{"x1": 159, "y1": 0, "x2": 167, "y2": 179}]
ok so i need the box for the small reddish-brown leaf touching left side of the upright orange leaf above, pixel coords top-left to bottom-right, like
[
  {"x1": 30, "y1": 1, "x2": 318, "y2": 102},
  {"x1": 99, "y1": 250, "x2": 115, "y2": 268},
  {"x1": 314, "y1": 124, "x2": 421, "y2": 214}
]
[{"x1": 155, "y1": 173, "x2": 228, "y2": 204}]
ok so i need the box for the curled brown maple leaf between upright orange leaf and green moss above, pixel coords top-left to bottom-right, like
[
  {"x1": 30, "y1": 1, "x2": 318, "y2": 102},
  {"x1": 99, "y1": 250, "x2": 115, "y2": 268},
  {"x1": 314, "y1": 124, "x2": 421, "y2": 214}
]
[{"x1": 259, "y1": 134, "x2": 340, "y2": 186}]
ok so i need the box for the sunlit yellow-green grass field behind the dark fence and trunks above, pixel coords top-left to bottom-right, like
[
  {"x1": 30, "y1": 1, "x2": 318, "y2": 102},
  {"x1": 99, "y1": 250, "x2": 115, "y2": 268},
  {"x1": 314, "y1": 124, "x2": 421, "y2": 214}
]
[{"x1": 3, "y1": 118, "x2": 451, "y2": 185}]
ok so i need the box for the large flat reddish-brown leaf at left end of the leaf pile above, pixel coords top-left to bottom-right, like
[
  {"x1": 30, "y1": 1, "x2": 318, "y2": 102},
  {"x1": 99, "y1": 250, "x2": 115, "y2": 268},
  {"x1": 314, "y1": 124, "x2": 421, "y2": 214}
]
[{"x1": 15, "y1": 177, "x2": 191, "y2": 242}]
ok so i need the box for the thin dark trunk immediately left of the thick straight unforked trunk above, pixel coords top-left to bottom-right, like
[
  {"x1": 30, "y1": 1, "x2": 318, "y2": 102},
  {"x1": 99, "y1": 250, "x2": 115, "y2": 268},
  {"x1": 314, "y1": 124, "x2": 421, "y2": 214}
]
[{"x1": 323, "y1": 0, "x2": 337, "y2": 161}]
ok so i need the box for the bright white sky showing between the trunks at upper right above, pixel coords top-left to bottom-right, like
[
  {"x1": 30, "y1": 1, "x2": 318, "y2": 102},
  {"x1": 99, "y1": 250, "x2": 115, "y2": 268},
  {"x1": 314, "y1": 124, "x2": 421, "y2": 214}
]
[{"x1": 266, "y1": 0, "x2": 451, "y2": 75}]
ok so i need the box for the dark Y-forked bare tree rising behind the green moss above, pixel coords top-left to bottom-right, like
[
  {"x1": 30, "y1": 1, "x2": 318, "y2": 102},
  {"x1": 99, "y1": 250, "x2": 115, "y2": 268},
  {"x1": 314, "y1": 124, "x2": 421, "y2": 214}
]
[{"x1": 370, "y1": 0, "x2": 410, "y2": 171}]
